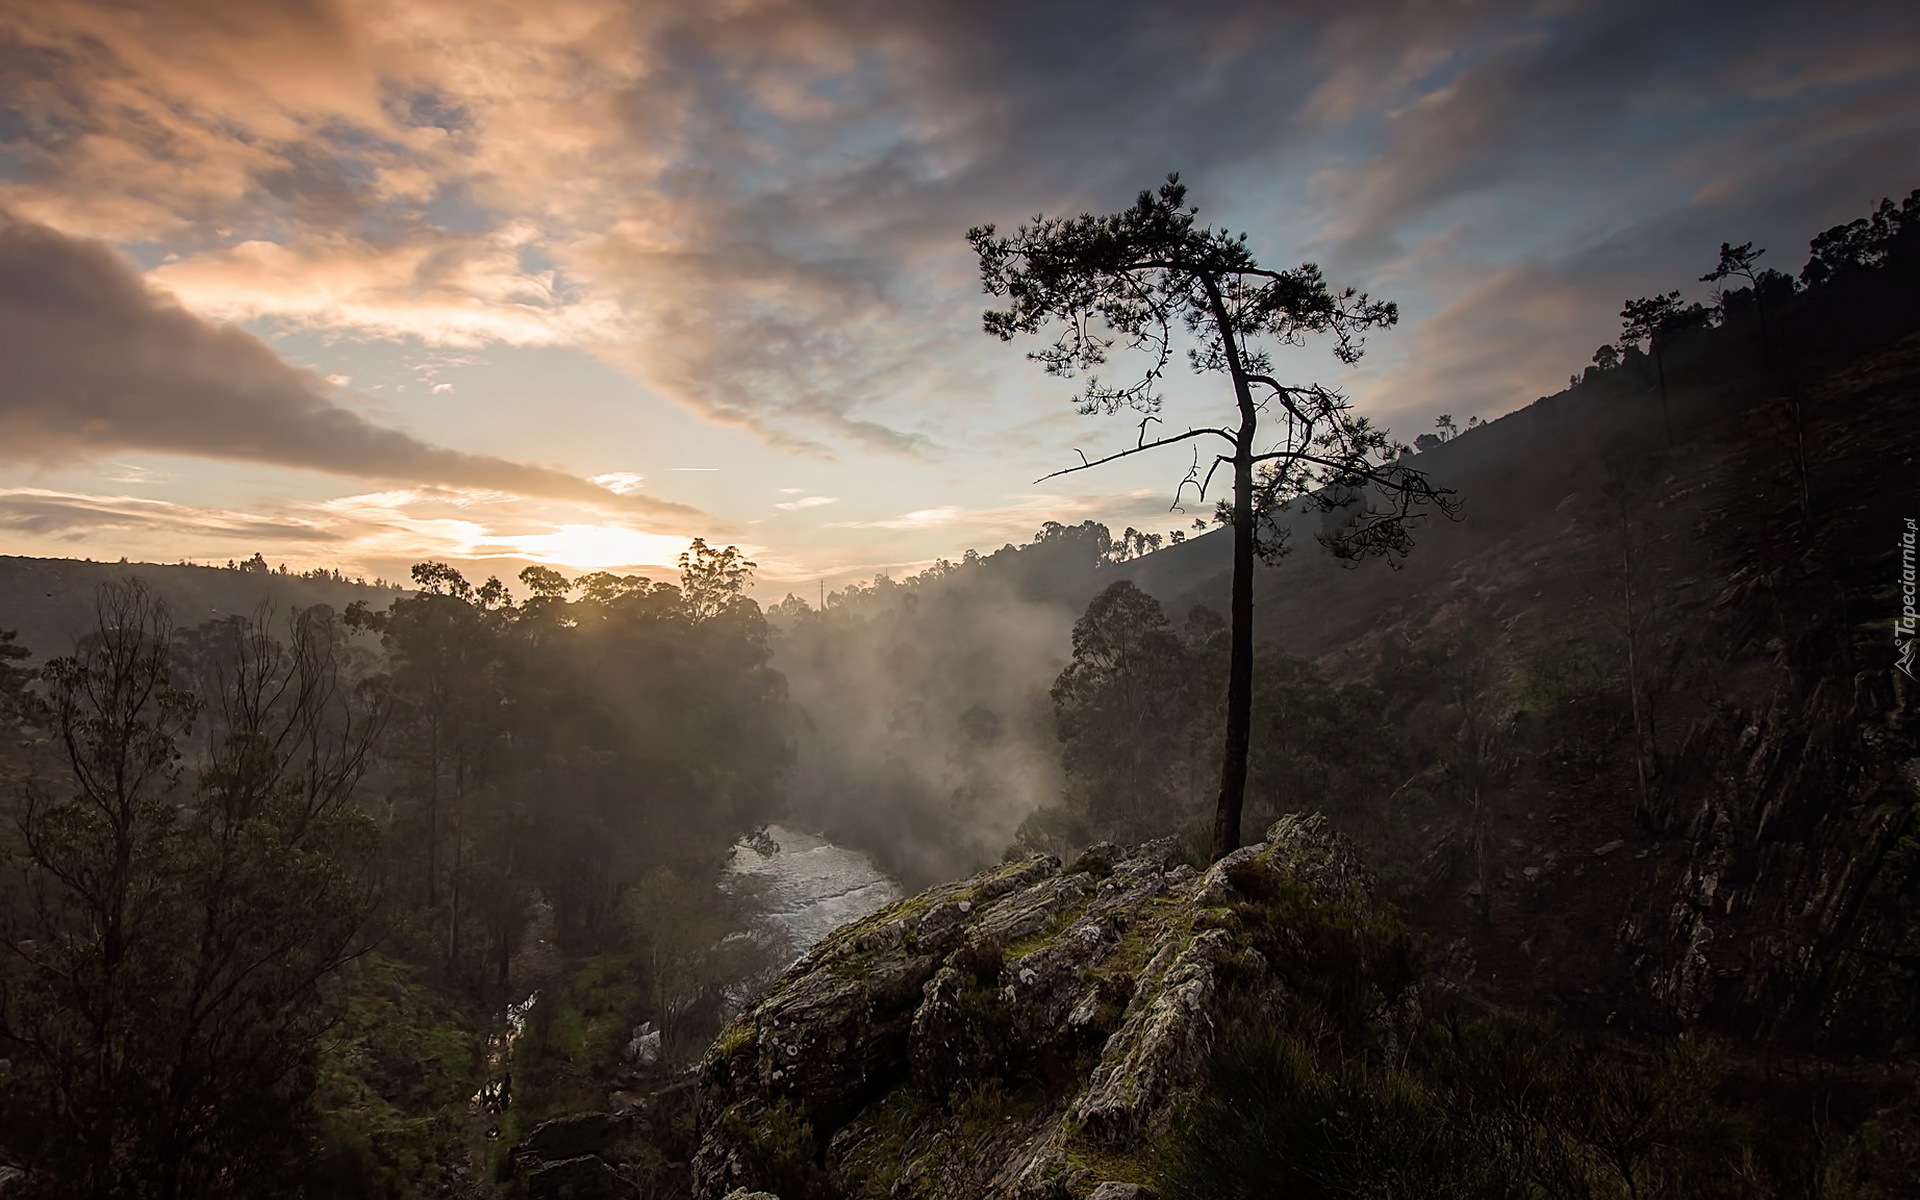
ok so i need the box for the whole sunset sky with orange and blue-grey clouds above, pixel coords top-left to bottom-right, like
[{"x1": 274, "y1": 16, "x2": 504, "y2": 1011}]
[{"x1": 0, "y1": 0, "x2": 1920, "y2": 599}]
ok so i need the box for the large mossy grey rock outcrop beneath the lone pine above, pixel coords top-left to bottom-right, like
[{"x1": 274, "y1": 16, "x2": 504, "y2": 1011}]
[{"x1": 693, "y1": 816, "x2": 1392, "y2": 1200}]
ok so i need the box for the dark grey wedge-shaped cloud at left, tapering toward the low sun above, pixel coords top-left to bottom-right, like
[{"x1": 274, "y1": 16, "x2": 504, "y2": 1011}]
[{"x1": 0, "y1": 215, "x2": 710, "y2": 528}]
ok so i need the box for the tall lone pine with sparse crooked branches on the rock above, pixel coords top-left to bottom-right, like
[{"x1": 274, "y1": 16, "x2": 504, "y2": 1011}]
[{"x1": 968, "y1": 175, "x2": 1450, "y2": 858}]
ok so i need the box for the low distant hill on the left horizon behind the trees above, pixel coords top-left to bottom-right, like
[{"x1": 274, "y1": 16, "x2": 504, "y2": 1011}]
[{"x1": 0, "y1": 555, "x2": 399, "y2": 659}]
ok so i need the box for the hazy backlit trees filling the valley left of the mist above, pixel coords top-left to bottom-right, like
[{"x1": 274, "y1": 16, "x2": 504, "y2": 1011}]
[{"x1": 0, "y1": 541, "x2": 789, "y2": 1198}]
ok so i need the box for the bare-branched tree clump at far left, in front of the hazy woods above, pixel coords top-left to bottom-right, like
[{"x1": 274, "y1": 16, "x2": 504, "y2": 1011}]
[{"x1": 0, "y1": 584, "x2": 380, "y2": 1198}]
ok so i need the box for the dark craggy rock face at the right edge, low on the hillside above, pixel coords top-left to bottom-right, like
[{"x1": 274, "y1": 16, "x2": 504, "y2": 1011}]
[{"x1": 1620, "y1": 656, "x2": 1920, "y2": 1054}]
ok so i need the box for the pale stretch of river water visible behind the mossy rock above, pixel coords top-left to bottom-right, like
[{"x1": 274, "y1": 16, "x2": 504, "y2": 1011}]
[{"x1": 728, "y1": 826, "x2": 900, "y2": 970}]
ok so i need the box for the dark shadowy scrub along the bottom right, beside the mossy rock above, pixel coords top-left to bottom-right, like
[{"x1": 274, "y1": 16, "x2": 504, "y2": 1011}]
[{"x1": 1154, "y1": 996, "x2": 1914, "y2": 1200}]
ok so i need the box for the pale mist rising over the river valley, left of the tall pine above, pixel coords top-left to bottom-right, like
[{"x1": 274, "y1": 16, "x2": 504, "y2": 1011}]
[{"x1": 772, "y1": 545, "x2": 1092, "y2": 889}]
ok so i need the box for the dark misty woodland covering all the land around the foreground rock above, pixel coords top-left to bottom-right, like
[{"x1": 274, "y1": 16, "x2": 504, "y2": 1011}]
[{"x1": 0, "y1": 190, "x2": 1920, "y2": 1200}]
